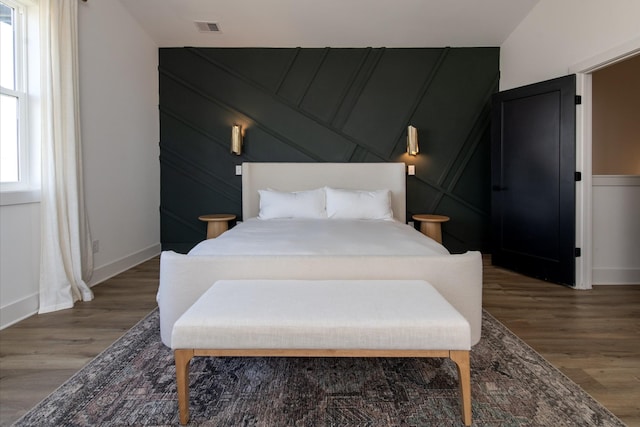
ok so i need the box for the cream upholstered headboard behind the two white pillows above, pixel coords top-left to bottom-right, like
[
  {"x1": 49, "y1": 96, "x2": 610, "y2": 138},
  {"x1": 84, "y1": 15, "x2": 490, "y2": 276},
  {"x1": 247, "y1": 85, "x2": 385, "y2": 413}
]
[{"x1": 242, "y1": 163, "x2": 407, "y2": 223}]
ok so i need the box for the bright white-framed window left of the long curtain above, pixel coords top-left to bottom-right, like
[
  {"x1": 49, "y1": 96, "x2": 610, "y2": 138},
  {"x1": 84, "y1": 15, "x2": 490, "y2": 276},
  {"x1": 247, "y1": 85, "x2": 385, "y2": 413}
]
[{"x1": 0, "y1": 0, "x2": 39, "y2": 204}]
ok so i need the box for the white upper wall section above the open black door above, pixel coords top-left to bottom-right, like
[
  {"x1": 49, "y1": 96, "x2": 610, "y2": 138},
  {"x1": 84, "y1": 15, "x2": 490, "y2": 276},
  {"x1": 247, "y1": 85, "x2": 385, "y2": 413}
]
[{"x1": 500, "y1": 0, "x2": 640, "y2": 90}]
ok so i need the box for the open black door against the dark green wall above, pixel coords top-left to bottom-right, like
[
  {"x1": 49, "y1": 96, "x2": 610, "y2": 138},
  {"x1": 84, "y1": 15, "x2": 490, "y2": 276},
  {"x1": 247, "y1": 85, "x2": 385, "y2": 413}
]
[{"x1": 491, "y1": 75, "x2": 576, "y2": 286}]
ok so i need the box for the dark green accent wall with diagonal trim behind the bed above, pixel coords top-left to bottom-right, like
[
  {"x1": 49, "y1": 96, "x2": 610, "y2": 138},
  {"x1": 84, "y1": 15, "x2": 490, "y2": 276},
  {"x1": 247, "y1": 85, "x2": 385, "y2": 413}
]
[{"x1": 159, "y1": 48, "x2": 499, "y2": 252}]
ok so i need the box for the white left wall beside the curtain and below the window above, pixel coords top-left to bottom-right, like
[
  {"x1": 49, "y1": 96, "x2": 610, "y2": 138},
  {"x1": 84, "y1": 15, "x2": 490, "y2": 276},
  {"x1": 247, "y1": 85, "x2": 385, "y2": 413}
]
[{"x1": 0, "y1": 0, "x2": 160, "y2": 328}]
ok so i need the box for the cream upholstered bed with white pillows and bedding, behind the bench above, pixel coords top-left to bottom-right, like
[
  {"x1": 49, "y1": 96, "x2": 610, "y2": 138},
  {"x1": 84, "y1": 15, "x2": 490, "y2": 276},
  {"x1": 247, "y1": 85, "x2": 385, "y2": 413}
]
[{"x1": 157, "y1": 163, "x2": 482, "y2": 346}]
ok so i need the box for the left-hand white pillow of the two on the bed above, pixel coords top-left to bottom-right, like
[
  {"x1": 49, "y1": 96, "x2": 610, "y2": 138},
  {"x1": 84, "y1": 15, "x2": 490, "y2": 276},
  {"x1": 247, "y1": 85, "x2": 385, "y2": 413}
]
[{"x1": 258, "y1": 188, "x2": 327, "y2": 219}]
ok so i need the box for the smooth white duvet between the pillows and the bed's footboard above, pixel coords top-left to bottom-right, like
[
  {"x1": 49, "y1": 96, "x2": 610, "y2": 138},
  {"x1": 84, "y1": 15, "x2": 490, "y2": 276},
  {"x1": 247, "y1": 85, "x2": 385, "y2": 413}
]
[{"x1": 189, "y1": 218, "x2": 449, "y2": 255}]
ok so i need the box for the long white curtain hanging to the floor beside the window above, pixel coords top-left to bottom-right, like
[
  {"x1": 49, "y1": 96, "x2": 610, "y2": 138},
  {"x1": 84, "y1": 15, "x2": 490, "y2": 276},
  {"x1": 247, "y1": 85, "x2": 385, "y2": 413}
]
[{"x1": 39, "y1": 0, "x2": 93, "y2": 313}]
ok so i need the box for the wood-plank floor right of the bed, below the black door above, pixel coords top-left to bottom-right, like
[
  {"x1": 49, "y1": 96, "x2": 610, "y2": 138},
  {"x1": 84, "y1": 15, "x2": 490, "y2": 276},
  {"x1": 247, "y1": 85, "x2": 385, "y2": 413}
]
[{"x1": 483, "y1": 258, "x2": 640, "y2": 426}]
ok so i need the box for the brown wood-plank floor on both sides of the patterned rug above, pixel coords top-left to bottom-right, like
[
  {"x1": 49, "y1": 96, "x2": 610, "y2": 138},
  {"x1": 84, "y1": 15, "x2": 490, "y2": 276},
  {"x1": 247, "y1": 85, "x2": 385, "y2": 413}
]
[{"x1": 0, "y1": 257, "x2": 640, "y2": 427}]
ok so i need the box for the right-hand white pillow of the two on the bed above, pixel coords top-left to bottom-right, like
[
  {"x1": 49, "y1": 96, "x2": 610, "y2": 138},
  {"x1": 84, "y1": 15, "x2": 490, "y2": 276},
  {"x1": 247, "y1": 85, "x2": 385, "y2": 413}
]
[{"x1": 326, "y1": 187, "x2": 393, "y2": 219}]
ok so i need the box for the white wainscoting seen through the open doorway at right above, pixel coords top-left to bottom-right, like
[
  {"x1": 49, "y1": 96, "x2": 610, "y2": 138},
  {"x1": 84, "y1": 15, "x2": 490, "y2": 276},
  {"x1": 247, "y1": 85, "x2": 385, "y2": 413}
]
[{"x1": 593, "y1": 175, "x2": 640, "y2": 285}]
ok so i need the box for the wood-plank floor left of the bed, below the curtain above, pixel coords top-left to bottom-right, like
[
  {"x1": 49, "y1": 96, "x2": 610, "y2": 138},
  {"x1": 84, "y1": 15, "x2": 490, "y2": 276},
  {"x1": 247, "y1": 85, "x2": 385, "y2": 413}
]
[{"x1": 0, "y1": 258, "x2": 160, "y2": 426}]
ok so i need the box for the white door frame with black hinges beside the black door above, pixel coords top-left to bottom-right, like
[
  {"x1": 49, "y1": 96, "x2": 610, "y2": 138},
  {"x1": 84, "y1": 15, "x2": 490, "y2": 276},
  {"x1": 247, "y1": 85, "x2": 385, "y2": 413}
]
[{"x1": 569, "y1": 37, "x2": 640, "y2": 289}]
